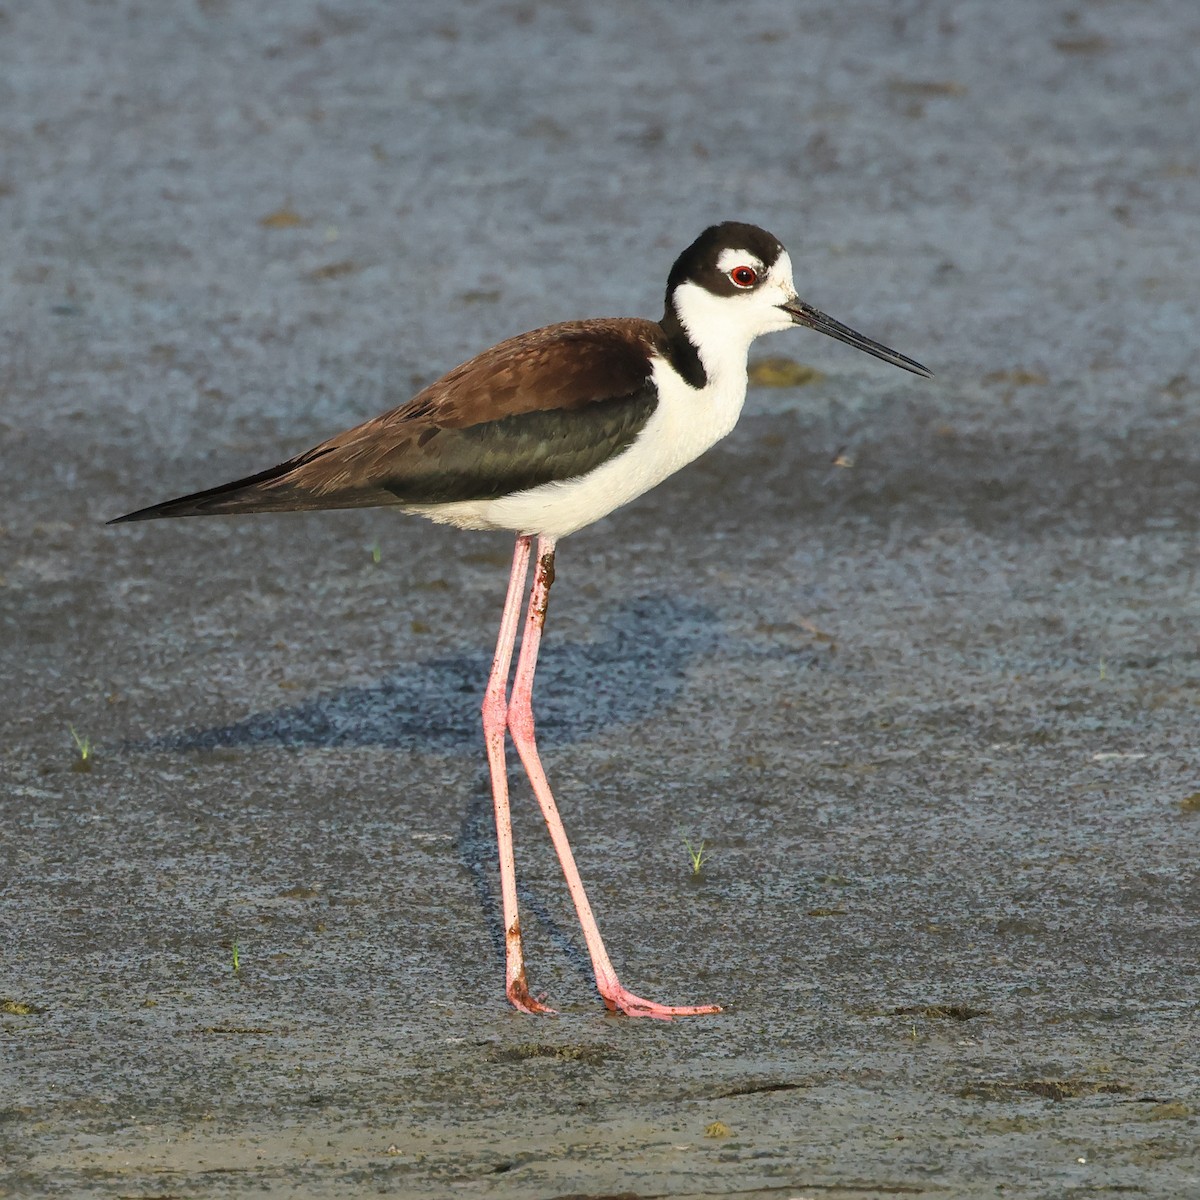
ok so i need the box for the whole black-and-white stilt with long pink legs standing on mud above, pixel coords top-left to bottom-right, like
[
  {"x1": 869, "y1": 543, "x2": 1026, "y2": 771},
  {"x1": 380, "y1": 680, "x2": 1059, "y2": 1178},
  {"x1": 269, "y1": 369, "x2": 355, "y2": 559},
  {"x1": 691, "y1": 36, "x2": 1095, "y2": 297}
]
[{"x1": 112, "y1": 222, "x2": 929, "y2": 1018}]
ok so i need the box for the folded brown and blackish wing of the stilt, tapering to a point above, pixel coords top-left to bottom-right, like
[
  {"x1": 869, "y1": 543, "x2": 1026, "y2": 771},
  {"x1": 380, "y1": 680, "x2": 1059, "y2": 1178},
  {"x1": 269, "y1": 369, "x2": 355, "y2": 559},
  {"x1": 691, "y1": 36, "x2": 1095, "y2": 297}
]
[{"x1": 109, "y1": 320, "x2": 665, "y2": 521}]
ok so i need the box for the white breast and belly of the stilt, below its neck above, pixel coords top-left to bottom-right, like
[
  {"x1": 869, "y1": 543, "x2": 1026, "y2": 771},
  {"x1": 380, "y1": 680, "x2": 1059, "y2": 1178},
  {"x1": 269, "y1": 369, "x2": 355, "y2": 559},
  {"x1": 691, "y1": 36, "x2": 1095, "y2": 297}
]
[{"x1": 406, "y1": 358, "x2": 746, "y2": 538}]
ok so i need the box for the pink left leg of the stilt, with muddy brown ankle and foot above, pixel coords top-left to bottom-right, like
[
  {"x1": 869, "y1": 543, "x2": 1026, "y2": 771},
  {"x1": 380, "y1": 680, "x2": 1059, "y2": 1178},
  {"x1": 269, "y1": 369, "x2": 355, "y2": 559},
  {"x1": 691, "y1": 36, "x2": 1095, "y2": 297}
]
[{"x1": 484, "y1": 538, "x2": 553, "y2": 1013}]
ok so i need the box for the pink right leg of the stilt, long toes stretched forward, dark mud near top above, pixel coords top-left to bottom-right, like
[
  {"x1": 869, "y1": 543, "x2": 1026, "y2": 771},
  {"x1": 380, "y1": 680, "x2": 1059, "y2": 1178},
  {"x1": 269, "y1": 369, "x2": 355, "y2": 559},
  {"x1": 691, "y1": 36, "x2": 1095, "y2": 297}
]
[{"x1": 508, "y1": 536, "x2": 721, "y2": 1019}]
